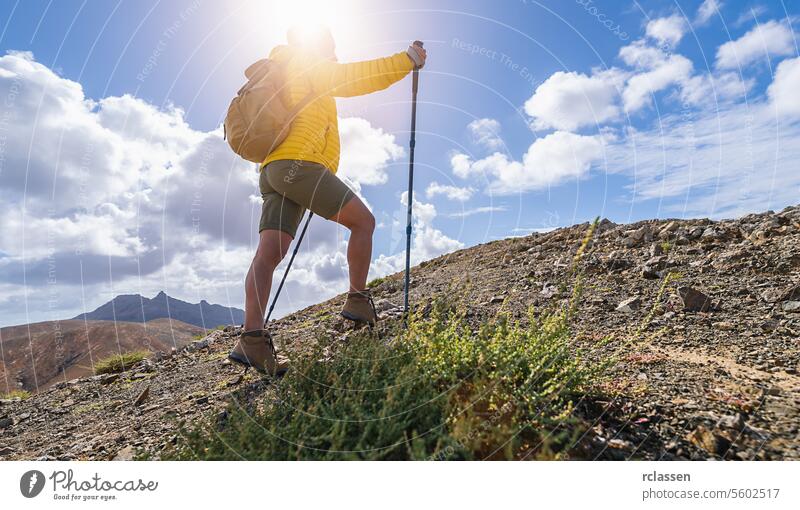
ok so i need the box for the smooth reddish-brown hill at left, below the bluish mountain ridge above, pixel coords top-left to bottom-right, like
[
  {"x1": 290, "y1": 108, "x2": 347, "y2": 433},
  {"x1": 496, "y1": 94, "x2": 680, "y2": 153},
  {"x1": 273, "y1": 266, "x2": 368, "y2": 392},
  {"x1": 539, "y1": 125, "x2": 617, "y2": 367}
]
[{"x1": 0, "y1": 319, "x2": 205, "y2": 393}]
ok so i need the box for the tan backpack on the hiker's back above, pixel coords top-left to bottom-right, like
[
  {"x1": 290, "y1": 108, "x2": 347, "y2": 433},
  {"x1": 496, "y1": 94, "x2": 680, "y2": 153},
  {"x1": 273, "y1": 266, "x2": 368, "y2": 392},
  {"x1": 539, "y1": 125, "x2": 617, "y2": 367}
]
[{"x1": 223, "y1": 58, "x2": 312, "y2": 163}]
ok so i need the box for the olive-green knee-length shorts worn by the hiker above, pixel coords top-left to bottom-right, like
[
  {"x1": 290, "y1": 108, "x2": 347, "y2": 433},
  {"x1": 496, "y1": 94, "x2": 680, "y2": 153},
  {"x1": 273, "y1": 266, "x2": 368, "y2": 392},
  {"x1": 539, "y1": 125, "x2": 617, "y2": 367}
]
[{"x1": 258, "y1": 159, "x2": 356, "y2": 237}]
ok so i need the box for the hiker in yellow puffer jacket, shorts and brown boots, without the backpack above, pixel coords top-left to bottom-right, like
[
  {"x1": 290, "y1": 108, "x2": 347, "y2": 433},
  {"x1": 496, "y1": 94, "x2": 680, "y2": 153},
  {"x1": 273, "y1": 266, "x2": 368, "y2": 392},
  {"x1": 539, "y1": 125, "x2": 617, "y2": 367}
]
[{"x1": 229, "y1": 28, "x2": 427, "y2": 375}]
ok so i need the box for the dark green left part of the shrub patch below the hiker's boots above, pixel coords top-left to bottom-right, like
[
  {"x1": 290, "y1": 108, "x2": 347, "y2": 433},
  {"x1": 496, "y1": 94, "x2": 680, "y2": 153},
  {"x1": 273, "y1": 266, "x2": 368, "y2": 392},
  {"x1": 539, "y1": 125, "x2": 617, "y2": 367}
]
[{"x1": 162, "y1": 328, "x2": 456, "y2": 460}]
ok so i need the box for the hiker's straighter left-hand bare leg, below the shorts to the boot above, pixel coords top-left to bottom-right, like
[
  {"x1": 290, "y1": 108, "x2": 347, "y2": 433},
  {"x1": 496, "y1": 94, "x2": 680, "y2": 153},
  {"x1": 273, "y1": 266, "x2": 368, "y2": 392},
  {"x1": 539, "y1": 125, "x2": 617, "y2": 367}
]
[{"x1": 244, "y1": 230, "x2": 292, "y2": 331}]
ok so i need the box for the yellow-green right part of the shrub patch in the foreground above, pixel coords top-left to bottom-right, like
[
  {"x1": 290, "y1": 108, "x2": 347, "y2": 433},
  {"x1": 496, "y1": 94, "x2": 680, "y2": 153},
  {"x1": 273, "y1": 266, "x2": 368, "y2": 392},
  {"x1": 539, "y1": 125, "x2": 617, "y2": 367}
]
[{"x1": 411, "y1": 300, "x2": 607, "y2": 458}]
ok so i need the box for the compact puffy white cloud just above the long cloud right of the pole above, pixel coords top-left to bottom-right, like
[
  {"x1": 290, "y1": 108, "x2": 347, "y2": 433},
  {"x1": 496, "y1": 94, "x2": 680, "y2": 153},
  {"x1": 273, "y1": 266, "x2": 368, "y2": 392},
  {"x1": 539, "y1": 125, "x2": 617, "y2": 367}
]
[{"x1": 525, "y1": 70, "x2": 624, "y2": 131}]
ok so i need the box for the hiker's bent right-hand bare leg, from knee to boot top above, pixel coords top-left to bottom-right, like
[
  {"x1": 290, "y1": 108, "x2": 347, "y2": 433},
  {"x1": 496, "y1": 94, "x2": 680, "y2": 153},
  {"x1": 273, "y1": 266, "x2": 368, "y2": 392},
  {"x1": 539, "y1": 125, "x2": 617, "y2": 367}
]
[{"x1": 328, "y1": 197, "x2": 375, "y2": 291}]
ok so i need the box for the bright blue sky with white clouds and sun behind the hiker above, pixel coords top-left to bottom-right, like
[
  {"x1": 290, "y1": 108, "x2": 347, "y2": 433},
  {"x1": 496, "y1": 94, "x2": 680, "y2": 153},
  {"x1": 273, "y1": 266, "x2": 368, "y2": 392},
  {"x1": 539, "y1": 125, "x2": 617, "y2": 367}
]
[{"x1": 0, "y1": 0, "x2": 800, "y2": 325}]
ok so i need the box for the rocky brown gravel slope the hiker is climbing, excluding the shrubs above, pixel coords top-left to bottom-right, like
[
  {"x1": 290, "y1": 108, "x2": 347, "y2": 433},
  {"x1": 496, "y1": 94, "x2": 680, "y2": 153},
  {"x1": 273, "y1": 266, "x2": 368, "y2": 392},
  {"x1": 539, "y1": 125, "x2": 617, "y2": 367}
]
[{"x1": 0, "y1": 207, "x2": 800, "y2": 459}]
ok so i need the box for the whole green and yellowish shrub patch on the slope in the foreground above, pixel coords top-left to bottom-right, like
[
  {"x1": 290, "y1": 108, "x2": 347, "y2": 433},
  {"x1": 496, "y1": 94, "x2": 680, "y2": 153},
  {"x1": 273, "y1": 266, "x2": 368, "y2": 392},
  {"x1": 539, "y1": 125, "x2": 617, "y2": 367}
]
[{"x1": 162, "y1": 303, "x2": 604, "y2": 460}]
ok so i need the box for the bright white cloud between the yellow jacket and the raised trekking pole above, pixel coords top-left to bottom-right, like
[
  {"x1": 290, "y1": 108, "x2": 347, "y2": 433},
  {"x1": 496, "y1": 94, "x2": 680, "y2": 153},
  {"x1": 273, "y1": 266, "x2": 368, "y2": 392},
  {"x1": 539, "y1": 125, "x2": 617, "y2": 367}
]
[{"x1": 339, "y1": 117, "x2": 405, "y2": 185}]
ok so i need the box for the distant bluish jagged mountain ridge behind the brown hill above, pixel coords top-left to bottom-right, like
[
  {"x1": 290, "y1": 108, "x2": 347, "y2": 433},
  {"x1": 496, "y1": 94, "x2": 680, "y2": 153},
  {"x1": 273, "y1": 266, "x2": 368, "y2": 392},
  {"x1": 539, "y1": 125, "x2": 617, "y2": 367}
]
[{"x1": 74, "y1": 290, "x2": 244, "y2": 329}]
